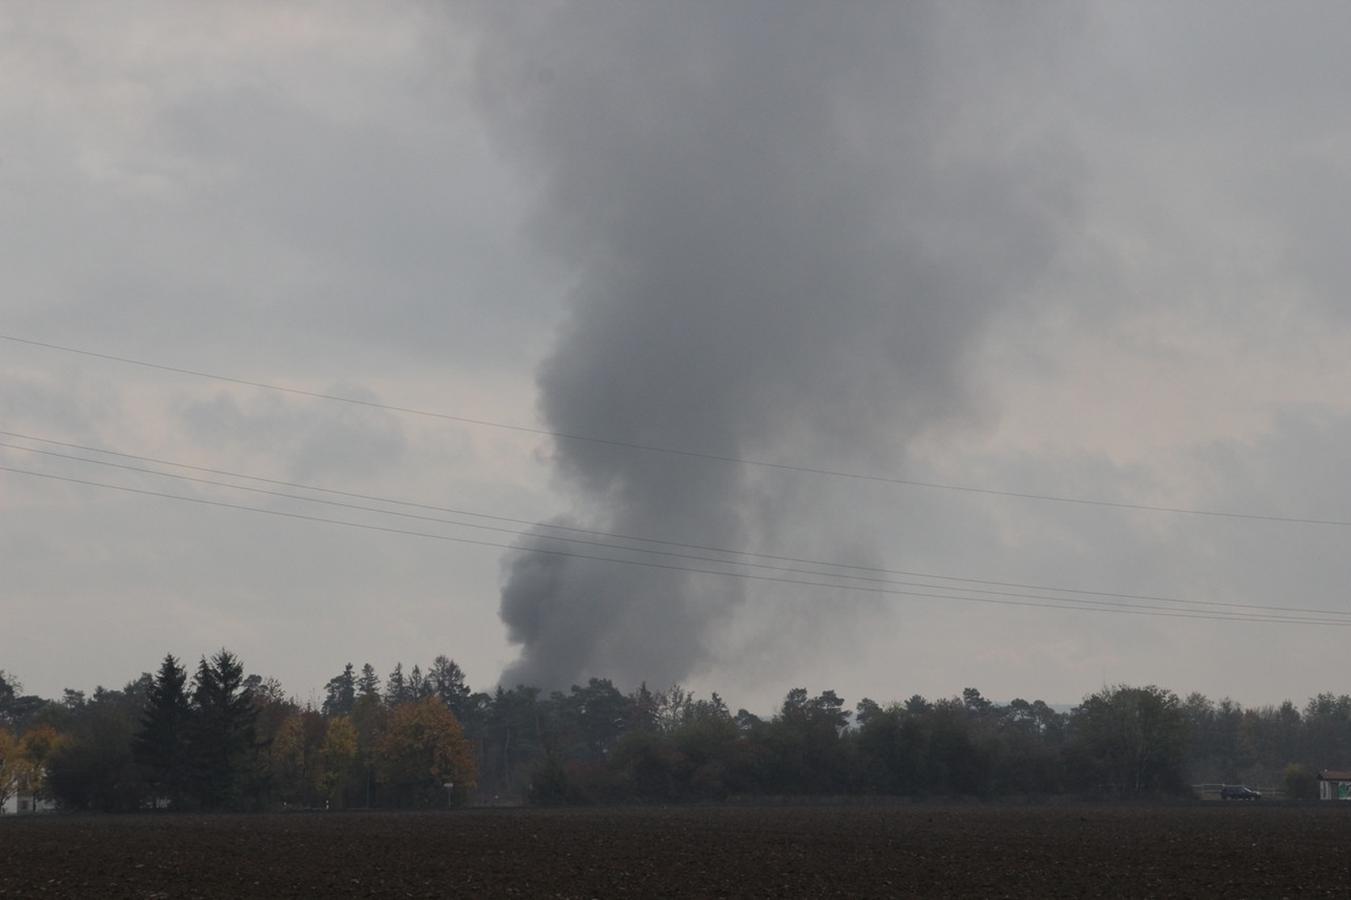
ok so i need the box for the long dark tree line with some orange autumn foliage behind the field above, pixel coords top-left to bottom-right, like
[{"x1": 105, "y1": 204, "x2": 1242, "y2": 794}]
[{"x1": 0, "y1": 650, "x2": 1351, "y2": 811}]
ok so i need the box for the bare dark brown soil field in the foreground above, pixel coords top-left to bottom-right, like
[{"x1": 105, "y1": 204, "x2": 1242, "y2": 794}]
[{"x1": 0, "y1": 803, "x2": 1351, "y2": 900}]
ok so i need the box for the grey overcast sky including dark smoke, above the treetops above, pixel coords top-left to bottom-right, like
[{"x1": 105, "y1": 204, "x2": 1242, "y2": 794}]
[{"x1": 0, "y1": 0, "x2": 1351, "y2": 708}]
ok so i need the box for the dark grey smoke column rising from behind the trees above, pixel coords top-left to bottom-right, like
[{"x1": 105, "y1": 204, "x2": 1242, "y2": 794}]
[{"x1": 473, "y1": 0, "x2": 1073, "y2": 688}]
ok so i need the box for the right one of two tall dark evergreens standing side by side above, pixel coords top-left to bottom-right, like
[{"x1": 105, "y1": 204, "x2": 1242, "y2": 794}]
[{"x1": 192, "y1": 649, "x2": 257, "y2": 808}]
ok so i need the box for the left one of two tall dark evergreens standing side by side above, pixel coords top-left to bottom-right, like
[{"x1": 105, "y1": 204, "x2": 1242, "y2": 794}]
[{"x1": 132, "y1": 653, "x2": 192, "y2": 805}]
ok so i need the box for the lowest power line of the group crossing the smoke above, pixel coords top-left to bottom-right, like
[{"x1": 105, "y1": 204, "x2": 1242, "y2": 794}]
[{"x1": 0, "y1": 465, "x2": 1351, "y2": 627}]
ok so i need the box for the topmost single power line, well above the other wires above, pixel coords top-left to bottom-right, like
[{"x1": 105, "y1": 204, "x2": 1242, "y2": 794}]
[{"x1": 0, "y1": 334, "x2": 1329, "y2": 527}]
